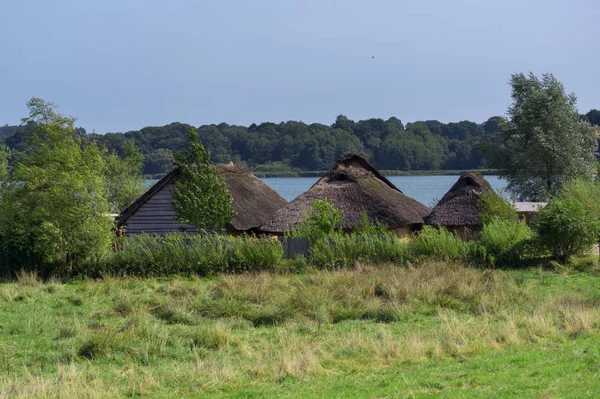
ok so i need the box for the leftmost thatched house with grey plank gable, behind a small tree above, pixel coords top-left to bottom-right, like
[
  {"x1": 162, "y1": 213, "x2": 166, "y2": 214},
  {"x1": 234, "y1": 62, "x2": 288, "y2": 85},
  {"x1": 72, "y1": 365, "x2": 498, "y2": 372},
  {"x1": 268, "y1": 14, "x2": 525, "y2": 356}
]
[{"x1": 117, "y1": 164, "x2": 287, "y2": 234}]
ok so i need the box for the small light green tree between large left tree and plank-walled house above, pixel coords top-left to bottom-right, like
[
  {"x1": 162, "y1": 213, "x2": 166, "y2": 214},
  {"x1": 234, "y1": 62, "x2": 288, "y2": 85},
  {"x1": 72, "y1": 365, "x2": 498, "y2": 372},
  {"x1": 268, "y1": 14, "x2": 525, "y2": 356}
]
[{"x1": 105, "y1": 140, "x2": 144, "y2": 213}]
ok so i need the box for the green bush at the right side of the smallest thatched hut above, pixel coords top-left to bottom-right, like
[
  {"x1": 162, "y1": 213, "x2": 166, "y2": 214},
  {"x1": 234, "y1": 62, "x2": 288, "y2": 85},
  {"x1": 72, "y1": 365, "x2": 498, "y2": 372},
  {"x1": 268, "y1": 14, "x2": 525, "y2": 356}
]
[{"x1": 477, "y1": 217, "x2": 533, "y2": 266}]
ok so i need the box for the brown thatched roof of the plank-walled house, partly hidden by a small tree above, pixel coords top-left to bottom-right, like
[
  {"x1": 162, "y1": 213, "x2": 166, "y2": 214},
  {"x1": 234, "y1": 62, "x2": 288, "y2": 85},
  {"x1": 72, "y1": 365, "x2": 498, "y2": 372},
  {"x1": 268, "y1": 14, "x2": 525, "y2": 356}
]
[{"x1": 117, "y1": 164, "x2": 287, "y2": 231}]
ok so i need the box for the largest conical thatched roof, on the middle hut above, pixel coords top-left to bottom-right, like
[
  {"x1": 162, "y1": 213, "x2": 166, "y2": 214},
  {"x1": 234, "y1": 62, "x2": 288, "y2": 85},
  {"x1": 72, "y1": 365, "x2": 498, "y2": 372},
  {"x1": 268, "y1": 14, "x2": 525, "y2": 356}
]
[{"x1": 259, "y1": 154, "x2": 429, "y2": 234}]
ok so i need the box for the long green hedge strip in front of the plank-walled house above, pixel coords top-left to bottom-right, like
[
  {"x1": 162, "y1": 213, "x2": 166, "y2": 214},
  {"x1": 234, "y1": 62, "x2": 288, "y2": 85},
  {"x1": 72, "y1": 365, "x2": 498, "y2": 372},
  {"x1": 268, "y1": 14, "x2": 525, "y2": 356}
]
[{"x1": 86, "y1": 233, "x2": 283, "y2": 277}]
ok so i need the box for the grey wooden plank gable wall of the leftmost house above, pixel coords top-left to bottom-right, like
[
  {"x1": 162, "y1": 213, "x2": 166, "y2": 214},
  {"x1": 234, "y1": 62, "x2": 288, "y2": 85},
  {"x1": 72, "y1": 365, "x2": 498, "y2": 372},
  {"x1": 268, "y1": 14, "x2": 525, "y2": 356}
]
[{"x1": 125, "y1": 184, "x2": 196, "y2": 235}]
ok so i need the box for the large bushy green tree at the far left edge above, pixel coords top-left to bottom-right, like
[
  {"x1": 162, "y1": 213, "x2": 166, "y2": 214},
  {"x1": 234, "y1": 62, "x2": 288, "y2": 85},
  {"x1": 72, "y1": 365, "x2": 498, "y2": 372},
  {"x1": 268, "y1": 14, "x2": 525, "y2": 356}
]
[{"x1": 0, "y1": 98, "x2": 114, "y2": 272}]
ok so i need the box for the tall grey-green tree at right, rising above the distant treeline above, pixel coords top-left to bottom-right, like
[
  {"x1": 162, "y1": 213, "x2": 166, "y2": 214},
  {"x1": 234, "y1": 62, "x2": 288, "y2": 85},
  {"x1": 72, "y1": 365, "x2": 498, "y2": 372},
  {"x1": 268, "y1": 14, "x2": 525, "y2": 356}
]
[{"x1": 490, "y1": 73, "x2": 598, "y2": 201}]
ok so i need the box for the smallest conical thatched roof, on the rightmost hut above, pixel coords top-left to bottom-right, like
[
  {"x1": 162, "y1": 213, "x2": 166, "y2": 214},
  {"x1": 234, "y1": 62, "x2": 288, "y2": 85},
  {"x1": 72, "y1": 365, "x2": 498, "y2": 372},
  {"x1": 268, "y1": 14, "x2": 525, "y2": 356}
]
[{"x1": 425, "y1": 172, "x2": 493, "y2": 226}]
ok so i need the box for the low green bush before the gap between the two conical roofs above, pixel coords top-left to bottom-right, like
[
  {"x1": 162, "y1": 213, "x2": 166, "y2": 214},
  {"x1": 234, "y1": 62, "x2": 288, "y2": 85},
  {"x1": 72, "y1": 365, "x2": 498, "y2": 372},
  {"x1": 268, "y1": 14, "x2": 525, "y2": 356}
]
[{"x1": 407, "y1": 226, "x2": 474, "y2": 262}]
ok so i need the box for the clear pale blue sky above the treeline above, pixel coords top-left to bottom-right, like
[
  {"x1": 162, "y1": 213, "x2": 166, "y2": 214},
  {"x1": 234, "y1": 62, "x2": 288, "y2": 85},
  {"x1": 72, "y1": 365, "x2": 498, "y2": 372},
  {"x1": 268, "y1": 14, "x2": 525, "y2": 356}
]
[{"x1": 0, "y1": 0, "x2": 600, "y2": 133}]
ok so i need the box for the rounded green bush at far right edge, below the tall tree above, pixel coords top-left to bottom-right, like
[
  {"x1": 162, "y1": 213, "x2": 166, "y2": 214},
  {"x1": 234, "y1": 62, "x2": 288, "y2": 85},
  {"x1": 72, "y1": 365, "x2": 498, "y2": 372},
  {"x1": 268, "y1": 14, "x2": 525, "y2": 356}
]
[{"x1": 535, "y1": 195, "x2": 600, "y2": 260}]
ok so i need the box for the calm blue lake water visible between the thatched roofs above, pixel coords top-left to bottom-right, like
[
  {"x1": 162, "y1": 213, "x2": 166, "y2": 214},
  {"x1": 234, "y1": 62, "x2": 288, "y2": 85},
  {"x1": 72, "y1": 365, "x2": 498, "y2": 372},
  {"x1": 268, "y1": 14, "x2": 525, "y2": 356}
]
[{"x1": 146, "y1": 176, "x2": 506, "y2": 206}]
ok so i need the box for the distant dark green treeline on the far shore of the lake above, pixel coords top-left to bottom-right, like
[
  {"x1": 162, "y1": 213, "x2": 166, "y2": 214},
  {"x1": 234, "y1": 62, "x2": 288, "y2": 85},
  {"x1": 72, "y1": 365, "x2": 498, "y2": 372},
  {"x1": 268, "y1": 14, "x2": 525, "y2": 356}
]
[{"x1": 0, "y1": 109, "x2": 600, "y2": 175}]
